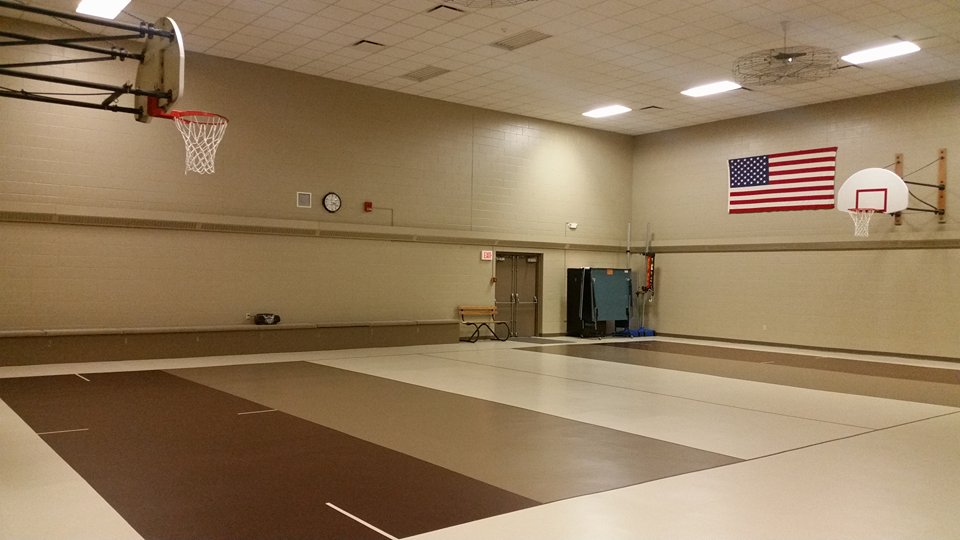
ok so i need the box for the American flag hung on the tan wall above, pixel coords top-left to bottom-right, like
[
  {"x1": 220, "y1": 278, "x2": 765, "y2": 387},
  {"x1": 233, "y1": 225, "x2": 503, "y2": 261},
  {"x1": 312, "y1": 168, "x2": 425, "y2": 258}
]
[{"x1": 727, "y1": 146, "x2": 837, "y2": 214}]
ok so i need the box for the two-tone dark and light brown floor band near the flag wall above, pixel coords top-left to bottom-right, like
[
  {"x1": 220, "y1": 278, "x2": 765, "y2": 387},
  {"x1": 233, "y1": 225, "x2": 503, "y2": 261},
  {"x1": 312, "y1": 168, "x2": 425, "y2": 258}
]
[{"x1": 520, "y1": 341, "x2": 960, "y2": 407}]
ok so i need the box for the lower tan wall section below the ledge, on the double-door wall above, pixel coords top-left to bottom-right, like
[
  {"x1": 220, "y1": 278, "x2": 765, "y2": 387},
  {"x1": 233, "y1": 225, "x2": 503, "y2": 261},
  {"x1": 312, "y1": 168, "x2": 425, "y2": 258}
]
[{"x1": 0, "y1": 223, "x2": 622, "y2": 333}]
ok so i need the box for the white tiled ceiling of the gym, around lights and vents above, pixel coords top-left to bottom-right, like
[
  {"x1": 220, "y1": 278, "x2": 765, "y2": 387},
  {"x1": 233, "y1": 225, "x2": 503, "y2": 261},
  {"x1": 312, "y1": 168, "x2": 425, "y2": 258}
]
[{"x1": 3, "y1": 0, "x2": 960, "y2": 134}]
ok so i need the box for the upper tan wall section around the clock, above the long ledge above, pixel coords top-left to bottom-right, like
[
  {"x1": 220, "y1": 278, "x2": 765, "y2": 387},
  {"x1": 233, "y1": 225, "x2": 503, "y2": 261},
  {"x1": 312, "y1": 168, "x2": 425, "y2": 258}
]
[{"x1": 0, "y1": 19, "x2": 632, "y2": 241}]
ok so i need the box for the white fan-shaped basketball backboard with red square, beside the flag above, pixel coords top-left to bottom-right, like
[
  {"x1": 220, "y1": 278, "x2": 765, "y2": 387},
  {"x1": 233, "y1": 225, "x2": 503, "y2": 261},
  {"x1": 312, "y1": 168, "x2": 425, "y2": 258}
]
[{"x1": 836, "y1": 168, "x2": 910, "y2": 214}]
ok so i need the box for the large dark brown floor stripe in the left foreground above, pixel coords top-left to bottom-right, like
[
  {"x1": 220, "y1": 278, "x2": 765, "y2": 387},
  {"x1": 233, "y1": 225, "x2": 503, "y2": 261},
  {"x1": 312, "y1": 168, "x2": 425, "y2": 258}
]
[{"x1": 0, "y1": 371, "x2": 537, "y2": 540}]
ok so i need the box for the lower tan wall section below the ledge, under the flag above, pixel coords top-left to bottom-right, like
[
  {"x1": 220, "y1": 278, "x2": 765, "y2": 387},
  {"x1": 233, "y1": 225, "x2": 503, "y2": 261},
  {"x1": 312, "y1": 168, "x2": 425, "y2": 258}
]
[{"x1": 648, "y1": 249, "x2": 960, "y2": 358}]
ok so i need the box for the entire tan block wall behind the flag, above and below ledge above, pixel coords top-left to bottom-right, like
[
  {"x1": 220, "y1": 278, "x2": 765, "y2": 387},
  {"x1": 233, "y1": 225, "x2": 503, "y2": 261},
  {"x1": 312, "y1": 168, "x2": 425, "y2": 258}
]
[{"x1": 633, "y1": 82, "x2": 960, "y2": 357}]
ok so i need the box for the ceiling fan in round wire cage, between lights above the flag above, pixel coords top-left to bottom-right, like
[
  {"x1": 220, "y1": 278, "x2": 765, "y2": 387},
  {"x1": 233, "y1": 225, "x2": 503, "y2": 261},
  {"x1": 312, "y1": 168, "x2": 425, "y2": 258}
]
[{"x1": 733, "y1": 21, "x2": 840, "y2": 86}]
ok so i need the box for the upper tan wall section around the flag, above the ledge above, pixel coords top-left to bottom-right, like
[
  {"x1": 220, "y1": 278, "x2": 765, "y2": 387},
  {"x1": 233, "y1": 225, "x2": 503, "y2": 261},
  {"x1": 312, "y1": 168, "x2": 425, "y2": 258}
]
[{"x1": 633, "y1": 82, "x2": 960, "y2": 244}]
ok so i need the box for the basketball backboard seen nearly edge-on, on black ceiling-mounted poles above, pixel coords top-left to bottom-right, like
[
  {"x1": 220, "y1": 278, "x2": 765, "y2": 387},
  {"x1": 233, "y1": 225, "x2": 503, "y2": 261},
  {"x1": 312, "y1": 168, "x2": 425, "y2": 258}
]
[{"x1": 134, "y1": 17, "x2": 183, "y2": 122}]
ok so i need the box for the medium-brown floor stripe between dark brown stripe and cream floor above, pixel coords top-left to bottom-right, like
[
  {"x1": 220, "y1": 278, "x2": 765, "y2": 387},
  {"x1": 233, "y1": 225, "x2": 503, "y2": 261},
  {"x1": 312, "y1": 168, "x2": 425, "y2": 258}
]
[{"x1": 171, "y1": 362, "x2": 739, "y2": 502}]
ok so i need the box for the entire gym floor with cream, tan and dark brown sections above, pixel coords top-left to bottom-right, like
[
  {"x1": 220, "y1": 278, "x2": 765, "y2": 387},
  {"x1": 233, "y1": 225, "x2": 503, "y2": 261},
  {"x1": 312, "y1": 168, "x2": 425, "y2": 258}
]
[{"x1": 0, "y1": 338, "x2": 960, "y2": 540}]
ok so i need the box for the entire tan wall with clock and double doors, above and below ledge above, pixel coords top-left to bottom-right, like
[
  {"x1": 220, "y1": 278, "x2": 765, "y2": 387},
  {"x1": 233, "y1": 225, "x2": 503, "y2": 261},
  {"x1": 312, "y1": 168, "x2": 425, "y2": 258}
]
[{"x1": 0, "y1": 20, "x2": 632, "y2": 333}]
